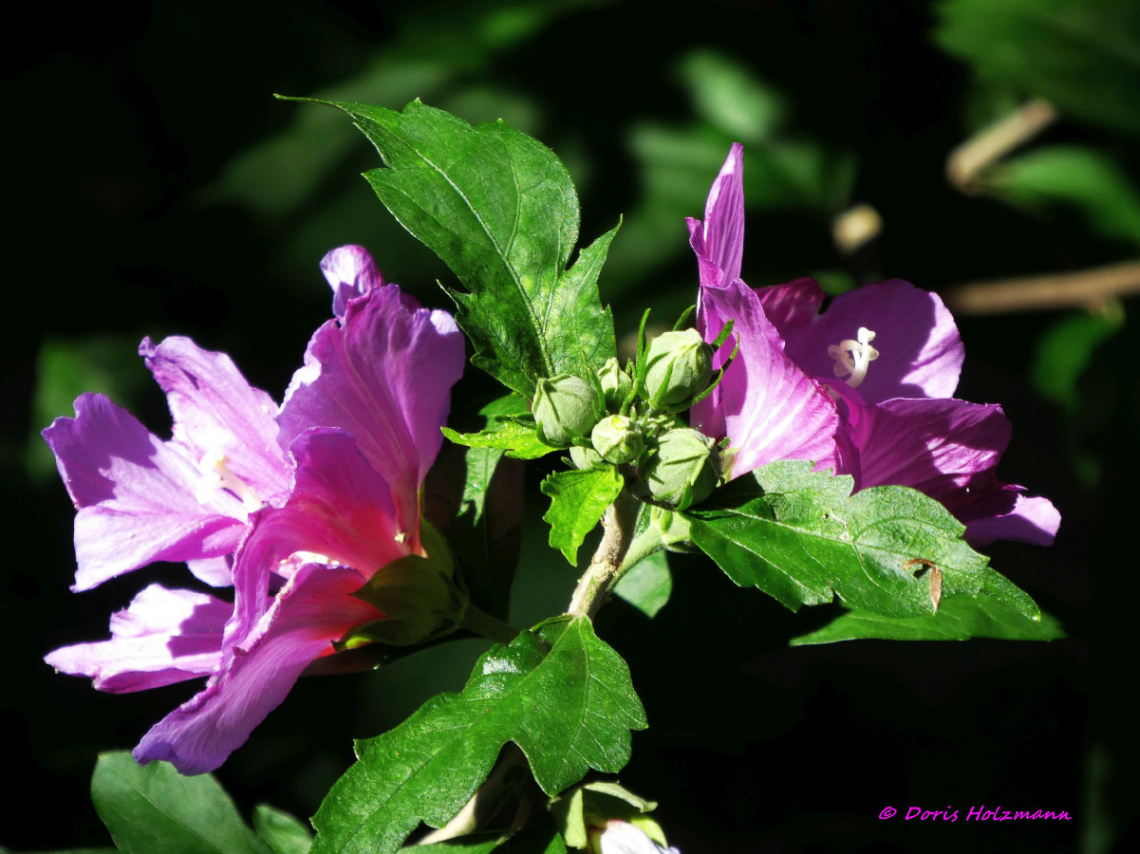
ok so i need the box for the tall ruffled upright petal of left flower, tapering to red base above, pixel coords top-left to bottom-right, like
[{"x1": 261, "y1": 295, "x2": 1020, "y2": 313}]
[{"x1": 278, "y1": 286, "x2": 464, "y2": 530}]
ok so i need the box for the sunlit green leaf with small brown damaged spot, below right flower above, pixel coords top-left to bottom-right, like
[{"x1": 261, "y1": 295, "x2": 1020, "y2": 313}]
[{"x1": 686, "y1": 461, "x2": 1040, "y2": 619}]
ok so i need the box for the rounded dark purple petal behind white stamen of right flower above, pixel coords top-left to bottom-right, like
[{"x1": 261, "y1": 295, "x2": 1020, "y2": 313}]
[{"x1": 785, "y1": 279, "x2": 964, "y2": 404}]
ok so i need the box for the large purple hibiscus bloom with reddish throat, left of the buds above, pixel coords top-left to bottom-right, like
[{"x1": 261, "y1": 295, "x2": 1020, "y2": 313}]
[{"x1": 44, "y1": 246, "x2": 464, "y2": 774}]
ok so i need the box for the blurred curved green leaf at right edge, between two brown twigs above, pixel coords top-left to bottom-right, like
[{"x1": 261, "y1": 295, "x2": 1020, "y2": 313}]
[{"x1": 985, "y1": 146, "x2": 1140, "y2": 246}]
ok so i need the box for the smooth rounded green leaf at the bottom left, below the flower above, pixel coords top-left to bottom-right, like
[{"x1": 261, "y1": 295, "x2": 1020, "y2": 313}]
[{"x1": 91, "y1": 753, "x2": 270, "y2": 854}]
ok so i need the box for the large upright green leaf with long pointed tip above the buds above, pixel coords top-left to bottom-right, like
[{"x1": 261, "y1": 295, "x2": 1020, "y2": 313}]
[{"x1": 326, "y1": 101, "x2": 617, "y2": 397}]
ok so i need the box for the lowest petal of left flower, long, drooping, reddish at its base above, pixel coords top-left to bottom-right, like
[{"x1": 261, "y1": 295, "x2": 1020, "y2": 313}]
[{"x1": 135, "y1": 564, "x2": 382, "y2": 774}]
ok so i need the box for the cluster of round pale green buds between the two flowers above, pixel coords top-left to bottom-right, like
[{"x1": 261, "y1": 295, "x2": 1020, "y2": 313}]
[{"x1": 532, "y1": 325, "x2": 731, "y2": 510}]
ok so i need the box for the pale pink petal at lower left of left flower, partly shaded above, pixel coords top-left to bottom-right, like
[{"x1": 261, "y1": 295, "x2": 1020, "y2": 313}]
[{"x1": 43, "y1": 584, "x2": 234, "y2": 693}]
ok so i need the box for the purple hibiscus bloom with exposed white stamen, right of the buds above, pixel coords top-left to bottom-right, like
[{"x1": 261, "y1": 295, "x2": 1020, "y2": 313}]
[{"x1": 689, "y1": 143, "x2": 1060, "y2": 545}]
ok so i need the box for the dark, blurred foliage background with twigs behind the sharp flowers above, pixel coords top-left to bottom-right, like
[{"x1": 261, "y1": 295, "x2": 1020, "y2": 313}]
[{"x1": 0, "y1": 0, "x2": 1140, "y2": 854}]
